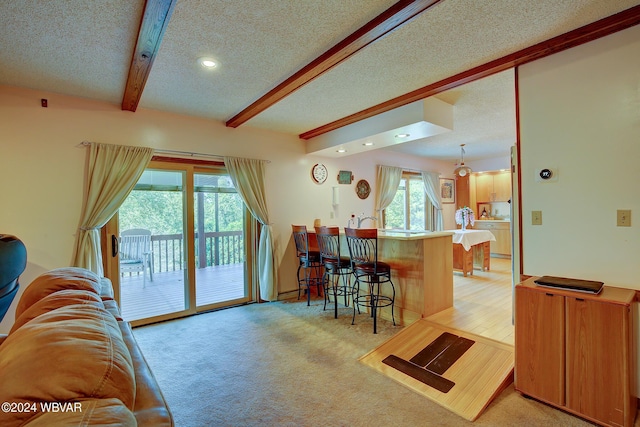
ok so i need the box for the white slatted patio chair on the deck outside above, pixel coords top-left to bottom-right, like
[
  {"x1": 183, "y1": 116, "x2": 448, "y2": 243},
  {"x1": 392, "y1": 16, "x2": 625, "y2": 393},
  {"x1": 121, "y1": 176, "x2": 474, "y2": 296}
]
[{"x1": 120, "y1": 228, "x2": 153, "y2": 287}]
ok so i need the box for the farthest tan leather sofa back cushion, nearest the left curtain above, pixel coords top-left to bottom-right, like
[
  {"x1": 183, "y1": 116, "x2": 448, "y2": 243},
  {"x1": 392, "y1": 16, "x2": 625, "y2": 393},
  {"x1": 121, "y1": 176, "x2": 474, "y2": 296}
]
[{"x1": 16, "y1": 267, "x2": 102, "y2": 319}]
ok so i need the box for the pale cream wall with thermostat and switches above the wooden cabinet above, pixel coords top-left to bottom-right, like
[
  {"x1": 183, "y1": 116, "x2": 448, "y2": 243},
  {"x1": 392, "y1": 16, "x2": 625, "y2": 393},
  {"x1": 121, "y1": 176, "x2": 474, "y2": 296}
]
[{"x1": 519, "y1": 26, "x2": 640, "y2": 289}]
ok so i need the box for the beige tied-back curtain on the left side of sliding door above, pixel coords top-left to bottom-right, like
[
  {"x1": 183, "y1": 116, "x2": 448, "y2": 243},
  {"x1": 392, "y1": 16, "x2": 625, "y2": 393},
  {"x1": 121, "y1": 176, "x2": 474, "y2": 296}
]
[{"x1": 72, "y1": 142, "x2": 153, "y2": 276}]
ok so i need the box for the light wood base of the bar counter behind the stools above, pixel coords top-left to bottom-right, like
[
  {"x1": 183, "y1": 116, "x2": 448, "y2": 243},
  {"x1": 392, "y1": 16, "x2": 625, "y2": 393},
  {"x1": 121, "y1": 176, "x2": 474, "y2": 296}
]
[{"x1": 378, "y1": 230, "x2": 453, "y2": 325}]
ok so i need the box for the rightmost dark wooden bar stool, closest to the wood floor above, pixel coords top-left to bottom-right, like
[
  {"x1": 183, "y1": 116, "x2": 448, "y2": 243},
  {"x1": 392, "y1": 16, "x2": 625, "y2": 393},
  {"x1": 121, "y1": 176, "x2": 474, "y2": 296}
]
[{"x1": 345, "y1": 228, "x2": 396, "y2": 334}]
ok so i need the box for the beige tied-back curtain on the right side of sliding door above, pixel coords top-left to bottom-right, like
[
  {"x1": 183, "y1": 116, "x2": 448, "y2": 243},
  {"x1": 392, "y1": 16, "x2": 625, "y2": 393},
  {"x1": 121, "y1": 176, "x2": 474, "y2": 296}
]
[{"x1": 224, "y1": 157, "x2": 278, "y2": 301}]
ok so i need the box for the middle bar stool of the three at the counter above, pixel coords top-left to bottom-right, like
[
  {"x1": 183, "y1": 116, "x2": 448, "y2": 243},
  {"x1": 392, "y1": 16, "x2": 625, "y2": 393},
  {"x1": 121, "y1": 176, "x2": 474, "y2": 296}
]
[{"x1": 315, "y1": 227, "x2": 356, "y2": 319}]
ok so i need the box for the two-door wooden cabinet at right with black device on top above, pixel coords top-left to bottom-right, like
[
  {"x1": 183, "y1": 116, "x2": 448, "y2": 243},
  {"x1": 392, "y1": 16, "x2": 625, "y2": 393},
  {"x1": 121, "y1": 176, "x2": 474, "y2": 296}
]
[{"x1": 515, "y1": 278, "x2": 637, "y2": 426}]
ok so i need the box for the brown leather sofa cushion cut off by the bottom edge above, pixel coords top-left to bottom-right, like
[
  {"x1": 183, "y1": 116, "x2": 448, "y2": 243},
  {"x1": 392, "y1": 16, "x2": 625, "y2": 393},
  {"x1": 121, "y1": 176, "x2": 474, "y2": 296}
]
[{"x1": 25, "y1": 399, "x2": 137, "y2": 427}]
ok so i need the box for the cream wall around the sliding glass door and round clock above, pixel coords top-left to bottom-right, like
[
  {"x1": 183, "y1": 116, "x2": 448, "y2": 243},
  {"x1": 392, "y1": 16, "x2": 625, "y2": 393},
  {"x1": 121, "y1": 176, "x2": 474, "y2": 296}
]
[{"x1": 0, "y1": 86, "x2": 453, "y2": 332}]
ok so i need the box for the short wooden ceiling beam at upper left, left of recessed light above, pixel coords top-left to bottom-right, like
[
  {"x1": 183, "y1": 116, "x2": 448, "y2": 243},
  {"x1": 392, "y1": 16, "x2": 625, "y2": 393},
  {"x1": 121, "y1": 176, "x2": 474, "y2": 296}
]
[{"x1": 122, "y1": 0, "x2": 178, "y2": 111}]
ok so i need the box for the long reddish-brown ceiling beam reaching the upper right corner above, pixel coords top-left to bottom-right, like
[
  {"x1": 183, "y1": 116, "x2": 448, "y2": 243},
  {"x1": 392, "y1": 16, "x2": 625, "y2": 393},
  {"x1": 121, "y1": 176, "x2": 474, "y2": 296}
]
[{"x1": 299, "y1": 5, "x2": 640, "y2": 139}]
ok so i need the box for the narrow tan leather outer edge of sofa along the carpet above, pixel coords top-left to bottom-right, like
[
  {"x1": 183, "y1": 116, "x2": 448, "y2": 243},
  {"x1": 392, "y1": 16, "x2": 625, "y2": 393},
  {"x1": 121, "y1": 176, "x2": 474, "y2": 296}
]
[{"x1": 118, "y1": 322, "x2": 174, "y2": 427}]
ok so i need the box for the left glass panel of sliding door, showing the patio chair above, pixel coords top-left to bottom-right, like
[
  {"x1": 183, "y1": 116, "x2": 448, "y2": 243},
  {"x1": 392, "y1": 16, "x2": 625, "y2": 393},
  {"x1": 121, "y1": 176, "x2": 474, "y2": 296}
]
[{"x1": 118, "y1": 170, "x2": 188, "y2": 321}]
